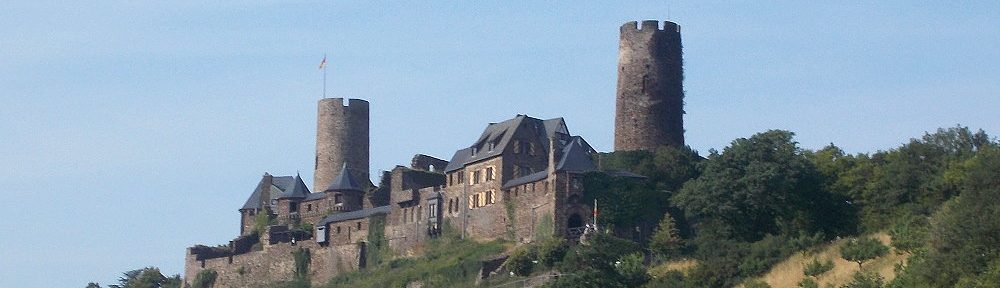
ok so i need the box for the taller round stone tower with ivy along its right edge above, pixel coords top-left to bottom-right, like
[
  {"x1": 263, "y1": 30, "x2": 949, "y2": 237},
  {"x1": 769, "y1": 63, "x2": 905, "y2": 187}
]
[{"x1": 615, "y1": 20, "x2": 684, "y2": 151}]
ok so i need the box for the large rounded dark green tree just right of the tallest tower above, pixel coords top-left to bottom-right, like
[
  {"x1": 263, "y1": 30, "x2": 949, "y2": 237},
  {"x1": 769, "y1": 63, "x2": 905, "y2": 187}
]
[{"x1": 671, "y1": 130, "x2": 839, "y2": 242}]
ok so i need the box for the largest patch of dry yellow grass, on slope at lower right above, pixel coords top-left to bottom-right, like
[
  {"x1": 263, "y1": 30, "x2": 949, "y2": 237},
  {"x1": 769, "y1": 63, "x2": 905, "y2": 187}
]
[{"x1": 758, "y1": 233, "x2": 909, "y2": 288}]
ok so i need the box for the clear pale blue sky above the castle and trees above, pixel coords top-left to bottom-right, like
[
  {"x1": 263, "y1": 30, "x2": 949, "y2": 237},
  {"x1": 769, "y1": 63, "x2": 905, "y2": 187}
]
[{"x1": 0, "y1": 1, "x2": 1000, "y2": 287}]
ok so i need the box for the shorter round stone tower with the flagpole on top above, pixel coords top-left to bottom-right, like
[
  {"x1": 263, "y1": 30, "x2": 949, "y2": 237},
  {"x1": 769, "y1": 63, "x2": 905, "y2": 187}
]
[{"x1": 313, "y1": 98, "x2": 370, "y2": 191}]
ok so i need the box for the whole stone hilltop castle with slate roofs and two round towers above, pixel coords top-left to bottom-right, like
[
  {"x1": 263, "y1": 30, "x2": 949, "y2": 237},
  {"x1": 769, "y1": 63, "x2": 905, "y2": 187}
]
[{"x1": 184, "y1": 21, "x2": 684, "y2": 287}]
